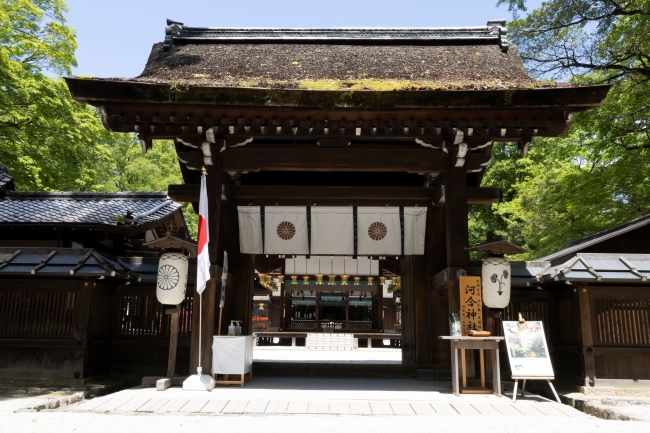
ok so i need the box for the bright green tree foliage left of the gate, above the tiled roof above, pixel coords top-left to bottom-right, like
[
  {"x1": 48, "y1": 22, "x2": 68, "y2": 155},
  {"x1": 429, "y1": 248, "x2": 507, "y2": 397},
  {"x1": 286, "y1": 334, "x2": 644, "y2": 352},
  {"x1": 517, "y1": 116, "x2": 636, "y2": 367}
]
[{"x1": 0, "y1": 0, "x2": 196, "y2": 233}]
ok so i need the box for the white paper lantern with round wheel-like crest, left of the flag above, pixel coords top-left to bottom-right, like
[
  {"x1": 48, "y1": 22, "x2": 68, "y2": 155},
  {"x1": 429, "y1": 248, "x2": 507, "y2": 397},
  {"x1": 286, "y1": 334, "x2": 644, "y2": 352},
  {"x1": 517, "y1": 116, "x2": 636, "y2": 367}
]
[{"x1": 156, "y1": 253, "x2": 189, "y2": 305}]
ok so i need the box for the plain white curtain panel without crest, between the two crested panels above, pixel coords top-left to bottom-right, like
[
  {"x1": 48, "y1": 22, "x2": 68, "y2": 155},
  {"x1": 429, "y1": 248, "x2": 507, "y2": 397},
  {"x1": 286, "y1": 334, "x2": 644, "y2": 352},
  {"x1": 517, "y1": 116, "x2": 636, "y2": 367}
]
[{"x1": 311, "y1": 206, "x2": 354, "y2": 255}]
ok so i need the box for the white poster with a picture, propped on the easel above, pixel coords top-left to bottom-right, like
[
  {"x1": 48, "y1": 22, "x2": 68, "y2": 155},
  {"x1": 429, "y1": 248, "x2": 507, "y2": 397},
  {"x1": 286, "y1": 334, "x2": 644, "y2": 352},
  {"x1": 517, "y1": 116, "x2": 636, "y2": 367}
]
[{"x1": 503, "y1": 321, "x2": 554, "y2": 378}]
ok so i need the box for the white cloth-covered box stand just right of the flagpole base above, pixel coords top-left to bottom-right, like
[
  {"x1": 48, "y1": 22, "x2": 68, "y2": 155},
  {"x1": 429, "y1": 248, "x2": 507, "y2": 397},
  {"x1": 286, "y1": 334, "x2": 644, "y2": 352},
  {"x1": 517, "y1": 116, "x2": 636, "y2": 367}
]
[{"x1": 212, "y1": 335, "x2": 255, "y2": 374}]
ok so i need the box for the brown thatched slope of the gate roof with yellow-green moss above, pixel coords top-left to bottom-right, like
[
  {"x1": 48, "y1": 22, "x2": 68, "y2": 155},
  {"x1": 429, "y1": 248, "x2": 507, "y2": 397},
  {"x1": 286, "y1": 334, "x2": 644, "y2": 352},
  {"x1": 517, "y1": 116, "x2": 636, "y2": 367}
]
[{"x1": 128, "y1": 43, "x2": 566, "y2": 91}]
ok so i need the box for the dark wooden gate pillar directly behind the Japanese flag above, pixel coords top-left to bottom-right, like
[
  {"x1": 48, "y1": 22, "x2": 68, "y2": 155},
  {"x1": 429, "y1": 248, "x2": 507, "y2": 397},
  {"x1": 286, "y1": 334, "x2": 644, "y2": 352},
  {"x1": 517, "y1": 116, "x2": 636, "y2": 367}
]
[{"x1": 190, "y1": 162, "x2": 223, "y2": 374}]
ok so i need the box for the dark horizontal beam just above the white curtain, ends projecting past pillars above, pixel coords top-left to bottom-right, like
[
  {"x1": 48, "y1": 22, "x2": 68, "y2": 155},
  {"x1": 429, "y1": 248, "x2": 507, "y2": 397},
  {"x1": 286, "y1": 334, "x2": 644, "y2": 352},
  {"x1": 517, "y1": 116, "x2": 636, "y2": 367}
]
[{"x1": 167, "y1": 184, "x2": 501, "y2": 205}]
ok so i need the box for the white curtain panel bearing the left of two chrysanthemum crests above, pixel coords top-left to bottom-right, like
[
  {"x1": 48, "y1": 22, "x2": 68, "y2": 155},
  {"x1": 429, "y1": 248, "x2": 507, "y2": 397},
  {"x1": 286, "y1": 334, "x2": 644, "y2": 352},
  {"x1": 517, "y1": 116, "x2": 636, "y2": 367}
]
[{"x1": 264, "y1": 206, "x2": 308, "y2": 254}]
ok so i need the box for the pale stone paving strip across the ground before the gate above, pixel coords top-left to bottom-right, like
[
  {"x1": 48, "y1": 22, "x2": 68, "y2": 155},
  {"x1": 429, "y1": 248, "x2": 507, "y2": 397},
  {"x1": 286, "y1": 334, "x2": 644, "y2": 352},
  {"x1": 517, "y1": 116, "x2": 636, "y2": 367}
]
[{"x1": 69, "y1": 377, "x2": 588, "y2": 418}]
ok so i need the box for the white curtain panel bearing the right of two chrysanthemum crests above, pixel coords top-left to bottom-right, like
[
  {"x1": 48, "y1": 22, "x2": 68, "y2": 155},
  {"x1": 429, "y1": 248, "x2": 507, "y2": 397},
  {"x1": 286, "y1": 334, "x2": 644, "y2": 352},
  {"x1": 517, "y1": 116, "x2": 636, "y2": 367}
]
[{"x1": 357, "y1": 207, "x2": 402, "y2": 256}]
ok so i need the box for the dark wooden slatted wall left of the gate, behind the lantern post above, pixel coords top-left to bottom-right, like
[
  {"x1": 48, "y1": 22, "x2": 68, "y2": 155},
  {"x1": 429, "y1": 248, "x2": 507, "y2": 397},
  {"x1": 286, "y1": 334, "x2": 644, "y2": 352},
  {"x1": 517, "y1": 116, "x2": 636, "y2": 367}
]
[{"x1": 0, "y1": 279, "x2": 193, "y2": 379}]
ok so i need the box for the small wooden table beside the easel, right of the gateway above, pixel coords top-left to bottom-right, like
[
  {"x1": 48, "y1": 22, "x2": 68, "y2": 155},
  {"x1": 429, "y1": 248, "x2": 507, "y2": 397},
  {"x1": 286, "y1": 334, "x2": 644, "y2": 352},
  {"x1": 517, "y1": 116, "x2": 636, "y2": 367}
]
[{"x1": 438, "y1": 335, "x2": 504, "y2": 396}]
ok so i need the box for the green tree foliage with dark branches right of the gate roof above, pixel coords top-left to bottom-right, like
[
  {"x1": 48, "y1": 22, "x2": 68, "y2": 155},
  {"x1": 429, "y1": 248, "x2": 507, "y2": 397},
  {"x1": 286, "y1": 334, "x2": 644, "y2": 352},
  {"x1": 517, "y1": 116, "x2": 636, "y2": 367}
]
[{"x1": 470, "y1": 0, "x2": 650, "y2": 258}]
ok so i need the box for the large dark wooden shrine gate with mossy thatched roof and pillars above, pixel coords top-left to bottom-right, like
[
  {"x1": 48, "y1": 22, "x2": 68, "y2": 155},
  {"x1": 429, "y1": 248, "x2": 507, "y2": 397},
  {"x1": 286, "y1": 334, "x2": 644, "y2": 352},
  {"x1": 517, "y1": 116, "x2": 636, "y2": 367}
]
[{"x1": 67, "y1": 21, "x2": 609, "y2": 371}]
